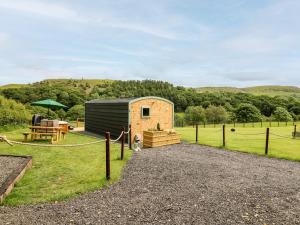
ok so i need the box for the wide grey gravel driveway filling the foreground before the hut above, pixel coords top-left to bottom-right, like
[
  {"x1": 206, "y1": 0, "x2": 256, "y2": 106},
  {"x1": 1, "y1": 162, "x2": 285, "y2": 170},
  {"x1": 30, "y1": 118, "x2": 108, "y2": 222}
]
[{"x1": 0, "y1": 144, "x2": 300, "y2": 225}]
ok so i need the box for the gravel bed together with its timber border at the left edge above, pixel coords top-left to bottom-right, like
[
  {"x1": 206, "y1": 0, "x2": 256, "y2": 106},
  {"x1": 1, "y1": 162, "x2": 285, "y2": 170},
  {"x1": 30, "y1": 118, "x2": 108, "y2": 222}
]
[{"x1": 0, "y1": 155, "x2": 32, "y2": 203}]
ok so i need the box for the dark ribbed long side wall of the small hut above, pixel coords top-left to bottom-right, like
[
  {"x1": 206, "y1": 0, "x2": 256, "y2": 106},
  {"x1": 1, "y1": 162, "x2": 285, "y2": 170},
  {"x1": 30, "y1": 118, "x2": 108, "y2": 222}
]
[{"x1": 85, "y1": 102, "x2": 128, "y2": 138}]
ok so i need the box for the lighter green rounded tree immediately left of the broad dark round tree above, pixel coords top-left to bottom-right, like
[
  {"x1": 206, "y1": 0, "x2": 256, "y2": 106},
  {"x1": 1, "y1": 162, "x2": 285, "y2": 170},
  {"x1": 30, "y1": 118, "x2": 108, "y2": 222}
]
[{"x1": 205, "y1": 105, "x2": 228, "y2": 123}]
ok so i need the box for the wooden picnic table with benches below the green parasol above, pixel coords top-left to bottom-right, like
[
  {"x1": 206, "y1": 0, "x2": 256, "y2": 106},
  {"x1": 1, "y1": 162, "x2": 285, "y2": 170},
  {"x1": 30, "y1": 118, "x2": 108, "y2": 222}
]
[{"x1": 23, "y1": 126, "x2": 65, "y2": 144}]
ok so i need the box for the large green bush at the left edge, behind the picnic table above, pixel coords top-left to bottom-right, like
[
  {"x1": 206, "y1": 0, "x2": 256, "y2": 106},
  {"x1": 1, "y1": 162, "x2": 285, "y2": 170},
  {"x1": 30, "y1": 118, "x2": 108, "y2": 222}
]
[{"x1": 0, "y1": 96, "x2": 31, "y2": 126}]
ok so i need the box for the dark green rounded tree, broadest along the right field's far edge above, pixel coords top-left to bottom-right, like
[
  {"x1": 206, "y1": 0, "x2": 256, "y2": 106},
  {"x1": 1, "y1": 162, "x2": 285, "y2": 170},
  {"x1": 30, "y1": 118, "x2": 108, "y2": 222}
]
[{"x1": 235, "y1": 103, "x2": 262, "y2": 123}]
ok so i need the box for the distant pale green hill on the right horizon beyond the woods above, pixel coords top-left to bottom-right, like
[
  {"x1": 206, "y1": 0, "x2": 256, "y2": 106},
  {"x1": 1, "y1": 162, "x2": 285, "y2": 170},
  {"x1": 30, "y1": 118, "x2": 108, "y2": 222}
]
[{"x1": 196, "y1": 85, "x2": 300, "y2": 98}]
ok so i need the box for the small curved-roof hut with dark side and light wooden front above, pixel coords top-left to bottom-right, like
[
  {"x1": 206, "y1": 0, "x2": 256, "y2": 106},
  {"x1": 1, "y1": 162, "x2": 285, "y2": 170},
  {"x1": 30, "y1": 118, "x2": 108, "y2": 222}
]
[{"x1": 85, "y1": 96, "x2": 174, "y2": 141}]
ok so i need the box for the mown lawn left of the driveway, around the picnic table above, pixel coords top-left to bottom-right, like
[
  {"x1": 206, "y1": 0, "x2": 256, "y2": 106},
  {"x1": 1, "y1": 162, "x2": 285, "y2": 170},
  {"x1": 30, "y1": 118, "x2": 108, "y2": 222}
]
[{"x1": 0, "y1": 129, "x2": 131, "y2": 205}]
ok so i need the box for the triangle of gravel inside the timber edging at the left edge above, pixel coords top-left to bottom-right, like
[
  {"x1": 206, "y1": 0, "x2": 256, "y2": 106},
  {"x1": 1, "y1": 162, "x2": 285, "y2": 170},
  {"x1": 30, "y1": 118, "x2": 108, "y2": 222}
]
[{"x1": 0, "y1": 156, "x2": 26, "y2": 187}]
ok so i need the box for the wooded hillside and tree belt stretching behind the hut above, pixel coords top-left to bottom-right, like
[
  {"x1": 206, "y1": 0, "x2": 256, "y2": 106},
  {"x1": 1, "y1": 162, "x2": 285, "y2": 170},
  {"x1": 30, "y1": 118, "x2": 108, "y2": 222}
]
[{"x1": 0, "y1": 79, "x2": 300, "y2": 125}]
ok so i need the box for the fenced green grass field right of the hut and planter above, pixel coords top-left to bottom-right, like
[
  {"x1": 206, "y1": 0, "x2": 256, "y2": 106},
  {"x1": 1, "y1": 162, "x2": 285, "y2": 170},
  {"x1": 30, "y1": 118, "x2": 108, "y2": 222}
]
[{"x1": 176, "y1": 125, "x2": 300, "y2": 161}]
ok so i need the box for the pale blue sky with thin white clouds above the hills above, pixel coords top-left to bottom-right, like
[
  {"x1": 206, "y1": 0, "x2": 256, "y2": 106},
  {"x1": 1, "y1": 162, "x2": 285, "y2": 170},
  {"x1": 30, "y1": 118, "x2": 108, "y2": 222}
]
[{"x1": 0, "y1": 0, "x2": 300, "y2": 87}]
